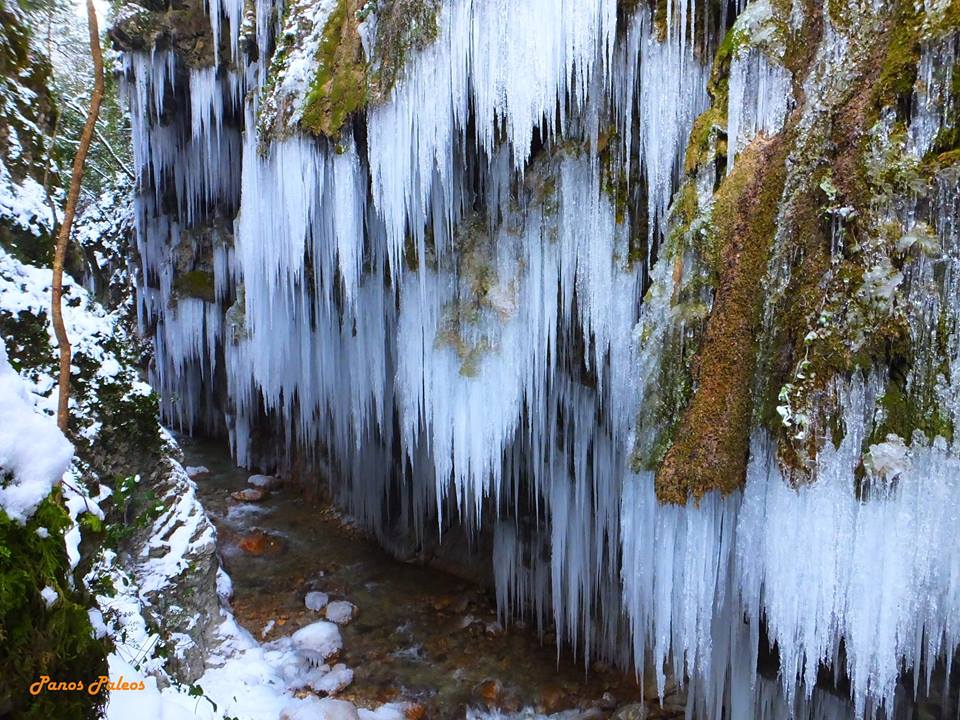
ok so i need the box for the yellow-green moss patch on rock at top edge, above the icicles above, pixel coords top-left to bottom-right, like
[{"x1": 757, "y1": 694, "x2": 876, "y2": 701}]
[{"x1": 301, "y1": 0, "x2": 367, "y2": 138}]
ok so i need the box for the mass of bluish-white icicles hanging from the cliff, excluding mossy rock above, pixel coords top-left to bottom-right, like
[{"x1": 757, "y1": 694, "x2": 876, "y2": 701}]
[{"x1": 124, "y1": 0, "x2": 960, "y2": 718}]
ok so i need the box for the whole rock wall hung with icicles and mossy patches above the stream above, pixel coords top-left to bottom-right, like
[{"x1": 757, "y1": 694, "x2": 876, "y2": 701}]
[{"x1": 114, "y1": 0, "x2": 960, "y2": 718}]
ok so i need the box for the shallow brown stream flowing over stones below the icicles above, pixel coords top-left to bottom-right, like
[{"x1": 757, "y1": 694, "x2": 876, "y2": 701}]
[{"x1": 181, "y1": 438, "x2": 681, "y2": 718}]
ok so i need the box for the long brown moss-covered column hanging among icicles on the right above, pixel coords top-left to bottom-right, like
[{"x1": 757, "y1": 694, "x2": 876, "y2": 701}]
[{"x1": 656, "y1": 139, "x2": 786, "y2": 504}]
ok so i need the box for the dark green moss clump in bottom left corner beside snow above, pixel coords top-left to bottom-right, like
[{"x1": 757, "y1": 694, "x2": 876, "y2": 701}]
[{"x1": 0, "y1": 491, "x2": 108, "y2": 720}]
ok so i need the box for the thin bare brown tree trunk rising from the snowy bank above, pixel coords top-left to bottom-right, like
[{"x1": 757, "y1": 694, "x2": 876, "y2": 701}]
[{"x1": 51, "y1": 0, "x2": 103, "y2": 432}]
